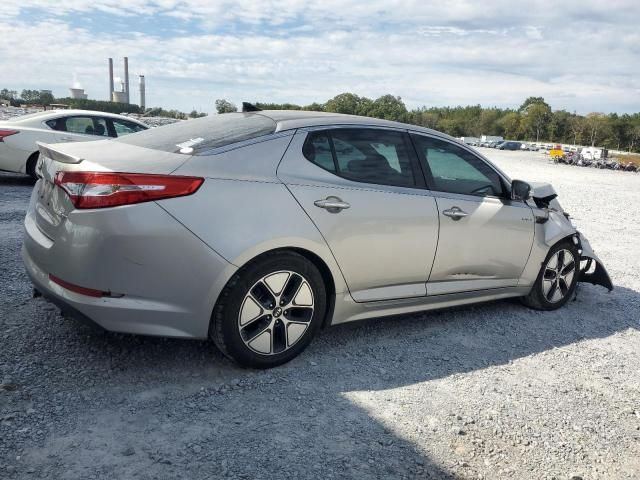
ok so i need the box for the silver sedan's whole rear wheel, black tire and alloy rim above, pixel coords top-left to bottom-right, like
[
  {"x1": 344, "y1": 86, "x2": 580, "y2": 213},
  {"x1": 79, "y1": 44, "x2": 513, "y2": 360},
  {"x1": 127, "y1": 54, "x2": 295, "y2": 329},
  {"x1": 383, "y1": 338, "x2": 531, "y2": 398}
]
[{"x1": 209, "y1": 251, "x2": 327, "y2": 368}]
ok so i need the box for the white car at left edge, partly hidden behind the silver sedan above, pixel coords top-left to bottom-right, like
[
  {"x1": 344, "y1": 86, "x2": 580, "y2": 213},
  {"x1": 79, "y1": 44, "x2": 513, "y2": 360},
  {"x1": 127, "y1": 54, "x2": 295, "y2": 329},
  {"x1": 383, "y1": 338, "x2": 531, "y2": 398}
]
[{"x1": 0, "y1": 110, "x2": 149, "y2": 178}]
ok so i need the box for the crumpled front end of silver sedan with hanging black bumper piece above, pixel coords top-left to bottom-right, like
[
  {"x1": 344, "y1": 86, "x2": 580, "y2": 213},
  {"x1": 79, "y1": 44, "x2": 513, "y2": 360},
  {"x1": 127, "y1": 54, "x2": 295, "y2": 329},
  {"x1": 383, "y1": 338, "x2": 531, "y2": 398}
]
[{"x1": 528, "y1": 183, "x2": 613, "y2": 291}]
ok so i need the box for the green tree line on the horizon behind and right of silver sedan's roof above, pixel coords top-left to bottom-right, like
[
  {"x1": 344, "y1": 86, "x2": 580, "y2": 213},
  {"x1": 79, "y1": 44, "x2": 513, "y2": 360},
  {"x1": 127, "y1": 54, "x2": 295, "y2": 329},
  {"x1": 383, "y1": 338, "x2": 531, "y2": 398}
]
[{"x1": 216, "y1": 93, "x2": 640, "y2": 152}]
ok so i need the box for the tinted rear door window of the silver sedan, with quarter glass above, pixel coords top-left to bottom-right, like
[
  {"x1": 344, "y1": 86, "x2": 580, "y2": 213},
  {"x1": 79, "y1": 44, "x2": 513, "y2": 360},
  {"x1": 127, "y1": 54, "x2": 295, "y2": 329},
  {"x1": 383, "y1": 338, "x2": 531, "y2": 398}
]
[{"x1": 303, "y1": 128, "x2": 416, "y2": 187}]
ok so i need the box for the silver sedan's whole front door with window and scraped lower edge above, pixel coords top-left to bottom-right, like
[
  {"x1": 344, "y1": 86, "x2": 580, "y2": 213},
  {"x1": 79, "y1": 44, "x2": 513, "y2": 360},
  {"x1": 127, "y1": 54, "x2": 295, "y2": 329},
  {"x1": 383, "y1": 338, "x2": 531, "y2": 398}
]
[{"x1": 411, "y1": 134, "x2": 535, "y2": 295}]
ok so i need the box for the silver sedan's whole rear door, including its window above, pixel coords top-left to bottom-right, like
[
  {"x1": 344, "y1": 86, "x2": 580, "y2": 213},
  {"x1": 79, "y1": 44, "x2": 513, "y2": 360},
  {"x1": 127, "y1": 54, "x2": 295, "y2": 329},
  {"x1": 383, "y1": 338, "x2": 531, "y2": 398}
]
[{"x1": 278, "y1": 128, "x2": 438, "y2": 302}]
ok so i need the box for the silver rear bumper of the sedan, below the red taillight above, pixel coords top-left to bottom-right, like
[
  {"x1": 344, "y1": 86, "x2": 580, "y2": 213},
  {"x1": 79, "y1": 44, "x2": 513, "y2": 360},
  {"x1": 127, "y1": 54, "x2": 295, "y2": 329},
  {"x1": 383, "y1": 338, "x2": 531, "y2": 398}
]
[{"x1": 22, "y1": 191, "x2": 236, "y2": 338}]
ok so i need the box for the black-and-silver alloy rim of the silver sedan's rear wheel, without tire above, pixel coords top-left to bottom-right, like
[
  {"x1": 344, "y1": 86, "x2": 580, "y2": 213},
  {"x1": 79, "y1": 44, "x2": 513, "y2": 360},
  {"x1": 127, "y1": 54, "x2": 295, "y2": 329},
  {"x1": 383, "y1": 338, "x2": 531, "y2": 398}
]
[{"x1": 238, "y1": 270, "x2": 314, "y2": 355}]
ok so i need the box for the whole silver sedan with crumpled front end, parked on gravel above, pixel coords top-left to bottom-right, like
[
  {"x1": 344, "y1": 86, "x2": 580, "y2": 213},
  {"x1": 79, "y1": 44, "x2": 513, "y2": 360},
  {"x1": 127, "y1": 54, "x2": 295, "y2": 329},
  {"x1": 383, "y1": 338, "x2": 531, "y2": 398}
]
[{"x1": 22, "y1": 111, "x2": 613, "y2": 368}]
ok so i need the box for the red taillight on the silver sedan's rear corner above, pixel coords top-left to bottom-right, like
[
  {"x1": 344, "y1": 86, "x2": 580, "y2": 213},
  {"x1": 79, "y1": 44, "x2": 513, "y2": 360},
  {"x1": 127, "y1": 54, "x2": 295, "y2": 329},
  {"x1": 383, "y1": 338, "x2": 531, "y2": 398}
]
[{"x1": 55, "y1": 172, "x2": 204, "y2": 208}]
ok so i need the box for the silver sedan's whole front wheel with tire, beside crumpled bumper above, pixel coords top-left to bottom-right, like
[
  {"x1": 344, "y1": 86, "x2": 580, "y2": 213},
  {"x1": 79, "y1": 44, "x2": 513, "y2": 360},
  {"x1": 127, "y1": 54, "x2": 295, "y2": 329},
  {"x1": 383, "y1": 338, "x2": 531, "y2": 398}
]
[{"x1": 521, "y1": 241, "x2": 580, "y2": 310}]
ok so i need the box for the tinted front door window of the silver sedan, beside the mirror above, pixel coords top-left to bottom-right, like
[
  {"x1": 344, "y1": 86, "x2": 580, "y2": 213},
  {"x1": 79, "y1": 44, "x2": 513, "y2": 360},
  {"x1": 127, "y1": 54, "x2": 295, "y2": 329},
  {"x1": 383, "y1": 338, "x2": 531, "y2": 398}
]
[{"x1": 412, "y1": 135, "x2": 504, "y2": 197}]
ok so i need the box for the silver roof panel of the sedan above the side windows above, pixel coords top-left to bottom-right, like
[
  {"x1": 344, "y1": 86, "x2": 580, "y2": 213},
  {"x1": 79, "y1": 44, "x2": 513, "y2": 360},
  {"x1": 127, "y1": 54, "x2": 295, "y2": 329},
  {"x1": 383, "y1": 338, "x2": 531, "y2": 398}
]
[{"x1": 255, "y1": 110, "x2": 460, "y2": 143}]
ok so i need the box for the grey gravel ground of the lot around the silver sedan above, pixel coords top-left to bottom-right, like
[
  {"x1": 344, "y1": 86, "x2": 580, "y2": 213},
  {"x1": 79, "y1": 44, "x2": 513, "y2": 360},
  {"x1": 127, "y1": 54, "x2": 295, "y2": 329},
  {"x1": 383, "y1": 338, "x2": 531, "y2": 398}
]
[{"x1": 0, "y1": 150, "x2": 640, "y2": 479}]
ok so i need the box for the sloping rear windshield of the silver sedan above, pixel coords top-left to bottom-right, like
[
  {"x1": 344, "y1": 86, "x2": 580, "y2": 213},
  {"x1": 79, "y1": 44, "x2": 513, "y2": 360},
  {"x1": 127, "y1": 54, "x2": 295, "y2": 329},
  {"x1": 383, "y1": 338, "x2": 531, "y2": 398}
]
[{"x1": 114, "y1": 113, "x2": 276, "y2": 155}]
